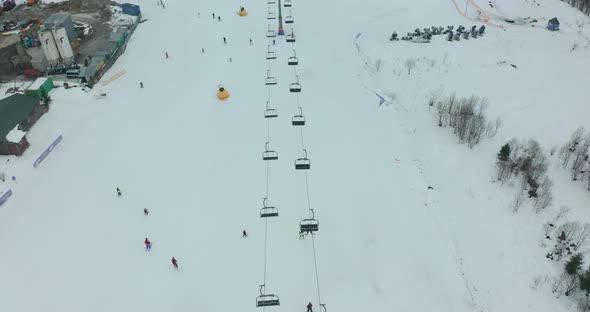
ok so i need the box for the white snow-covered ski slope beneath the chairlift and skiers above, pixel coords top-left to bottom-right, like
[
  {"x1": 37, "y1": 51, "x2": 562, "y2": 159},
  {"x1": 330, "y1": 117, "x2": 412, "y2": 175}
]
[{"x1": 0, "y1": 0, "x2": 590, "y2": 312}]
